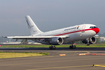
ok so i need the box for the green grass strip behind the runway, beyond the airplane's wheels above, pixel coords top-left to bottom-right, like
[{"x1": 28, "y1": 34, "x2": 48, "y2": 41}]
[{"x1": 1, "y1": 44, "x2": 105, "y2": 48}]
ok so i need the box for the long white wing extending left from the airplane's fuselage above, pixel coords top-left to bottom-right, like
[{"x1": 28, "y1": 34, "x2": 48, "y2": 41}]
[{"x1": 5, "y1": 35, "x2": 69, "y2": 39}]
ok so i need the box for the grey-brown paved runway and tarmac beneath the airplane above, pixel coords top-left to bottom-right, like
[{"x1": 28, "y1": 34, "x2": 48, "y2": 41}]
[{"x1": 0, "y1": 48, "x2": 105, "y2": 70}]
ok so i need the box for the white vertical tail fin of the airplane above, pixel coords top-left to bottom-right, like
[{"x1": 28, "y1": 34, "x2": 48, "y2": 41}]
[{"x1": 25, "y1": 16, "x2": 42, "y2": 35}]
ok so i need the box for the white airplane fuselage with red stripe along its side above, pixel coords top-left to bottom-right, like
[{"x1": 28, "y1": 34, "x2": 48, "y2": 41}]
[{"x1": 35, "y1": 24, "x2": 97, "y2": 43}]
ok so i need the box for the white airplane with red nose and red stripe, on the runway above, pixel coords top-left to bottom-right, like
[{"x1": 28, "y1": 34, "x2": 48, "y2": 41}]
[{"x1": 6, "y1": 15, "x2": 100, "y2": 49}]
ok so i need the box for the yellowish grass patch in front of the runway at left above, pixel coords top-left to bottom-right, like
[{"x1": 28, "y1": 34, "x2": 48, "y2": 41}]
[{"x1": 0, "y1": 52, "x2": 49, "y2": 59}]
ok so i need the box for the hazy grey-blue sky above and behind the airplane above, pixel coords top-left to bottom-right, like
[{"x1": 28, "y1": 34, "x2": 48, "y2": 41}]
[{"x1": 0, "y1": 0, "x2": 105, "y2": 36}]
